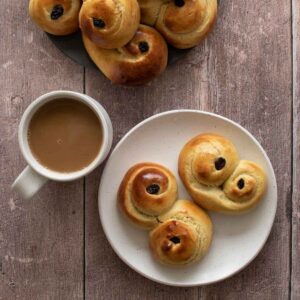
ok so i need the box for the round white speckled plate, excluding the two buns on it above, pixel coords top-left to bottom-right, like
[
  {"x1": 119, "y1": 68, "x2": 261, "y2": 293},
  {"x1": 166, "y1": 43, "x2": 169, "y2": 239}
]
[{"x1": 99, "y1": 110, "x2": 277, "y2": 286}]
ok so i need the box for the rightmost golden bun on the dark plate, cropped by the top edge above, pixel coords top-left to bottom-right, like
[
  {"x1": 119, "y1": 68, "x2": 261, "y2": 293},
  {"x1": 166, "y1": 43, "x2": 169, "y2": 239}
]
[{"x1": 138, "y1": 0, "x2": 217, "y2": 49}]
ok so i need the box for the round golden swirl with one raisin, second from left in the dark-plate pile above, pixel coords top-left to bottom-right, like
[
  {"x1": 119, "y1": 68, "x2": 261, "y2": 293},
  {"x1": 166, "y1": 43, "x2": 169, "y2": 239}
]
[{"x1": 79, "y1": 0, "x2": 140, "y2": 49}]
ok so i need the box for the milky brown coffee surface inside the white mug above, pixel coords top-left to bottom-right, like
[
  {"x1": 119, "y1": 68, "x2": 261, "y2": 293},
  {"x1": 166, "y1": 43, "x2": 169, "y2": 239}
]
[{"x1": 28, "y1": 99, "x2": 102, "y2": 173}]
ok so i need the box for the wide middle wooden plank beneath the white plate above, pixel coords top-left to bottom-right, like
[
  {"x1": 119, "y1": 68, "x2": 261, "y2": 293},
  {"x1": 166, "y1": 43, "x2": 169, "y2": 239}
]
[{"x1": 85, "y1": 0, "x2": 291, "y2": 299}]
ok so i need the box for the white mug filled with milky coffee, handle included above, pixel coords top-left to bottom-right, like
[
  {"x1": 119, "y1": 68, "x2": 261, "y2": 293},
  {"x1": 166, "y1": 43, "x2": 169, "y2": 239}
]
[{"x1": 12, "y1": 91, "x2": 113, "y2": 198}]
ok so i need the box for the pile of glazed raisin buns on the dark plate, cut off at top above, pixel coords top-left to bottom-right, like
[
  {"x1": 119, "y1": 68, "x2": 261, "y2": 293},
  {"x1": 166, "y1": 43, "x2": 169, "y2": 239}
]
[{"x1": 29, "y1": 0, "x2": 217, "y2": 86}]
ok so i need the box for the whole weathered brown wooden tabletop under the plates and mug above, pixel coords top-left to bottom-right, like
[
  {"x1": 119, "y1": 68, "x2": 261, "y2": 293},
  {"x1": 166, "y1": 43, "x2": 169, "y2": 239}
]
[{"x1": 0, "y1": 0, "x2": 300, "y2": 300}]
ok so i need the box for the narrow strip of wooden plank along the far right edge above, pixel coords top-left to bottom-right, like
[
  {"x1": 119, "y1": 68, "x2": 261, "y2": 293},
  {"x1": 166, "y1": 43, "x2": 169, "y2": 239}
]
[{"x1": 291, "y1": 0, "x2": 300, "y2": 300}]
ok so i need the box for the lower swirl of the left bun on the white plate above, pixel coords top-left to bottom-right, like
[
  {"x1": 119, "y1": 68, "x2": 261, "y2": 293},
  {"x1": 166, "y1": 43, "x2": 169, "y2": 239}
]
[{"x1": 150, "y1": 200, "x2": 213, "y2": 265}]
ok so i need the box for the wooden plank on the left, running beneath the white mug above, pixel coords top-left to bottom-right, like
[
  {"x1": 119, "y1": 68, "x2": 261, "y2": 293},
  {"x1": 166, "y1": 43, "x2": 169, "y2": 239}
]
[{"x1": 0, "y1": 0, "x2": 83, "y2": 300}]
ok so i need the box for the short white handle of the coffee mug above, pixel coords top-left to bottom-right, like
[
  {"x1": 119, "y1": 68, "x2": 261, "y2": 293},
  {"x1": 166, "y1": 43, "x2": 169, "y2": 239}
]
[{"x1": 12, "y1": 166, "x2": 48, "y2": 199}]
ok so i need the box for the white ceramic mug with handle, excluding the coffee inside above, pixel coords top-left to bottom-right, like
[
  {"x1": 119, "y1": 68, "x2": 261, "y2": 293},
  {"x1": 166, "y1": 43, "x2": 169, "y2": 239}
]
[{"x1": 12, "y1": 91, "x2": 113, "y2": 199}]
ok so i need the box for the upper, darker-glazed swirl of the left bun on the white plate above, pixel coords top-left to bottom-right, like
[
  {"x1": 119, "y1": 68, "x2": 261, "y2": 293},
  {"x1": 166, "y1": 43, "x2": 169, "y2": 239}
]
[{"x1": 118, "y1": 163, "x2": 177, "y2": 229}]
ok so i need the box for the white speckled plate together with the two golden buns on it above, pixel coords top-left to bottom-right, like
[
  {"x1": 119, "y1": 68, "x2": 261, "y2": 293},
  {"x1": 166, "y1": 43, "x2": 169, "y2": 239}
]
[{"x1": 98, "y1": 110, "x2": 277, "y2": 286}]
